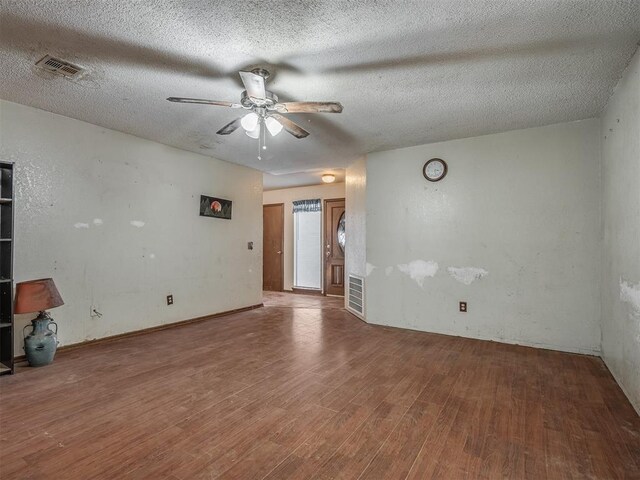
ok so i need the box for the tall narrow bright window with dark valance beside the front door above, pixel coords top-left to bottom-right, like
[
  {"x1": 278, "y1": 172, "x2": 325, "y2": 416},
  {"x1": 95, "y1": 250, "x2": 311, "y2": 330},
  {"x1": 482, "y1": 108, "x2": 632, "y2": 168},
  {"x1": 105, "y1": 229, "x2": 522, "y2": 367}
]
[{"x1": 293, "y1": 200, "x2": 322, "y2": 290}]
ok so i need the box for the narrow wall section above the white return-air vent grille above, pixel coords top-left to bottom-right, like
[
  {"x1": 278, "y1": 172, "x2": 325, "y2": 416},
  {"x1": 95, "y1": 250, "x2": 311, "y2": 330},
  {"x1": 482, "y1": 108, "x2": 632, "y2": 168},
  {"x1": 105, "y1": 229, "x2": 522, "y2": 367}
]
[{"x1": 345, "y1": 157, "x2": 367, "y2": 308}]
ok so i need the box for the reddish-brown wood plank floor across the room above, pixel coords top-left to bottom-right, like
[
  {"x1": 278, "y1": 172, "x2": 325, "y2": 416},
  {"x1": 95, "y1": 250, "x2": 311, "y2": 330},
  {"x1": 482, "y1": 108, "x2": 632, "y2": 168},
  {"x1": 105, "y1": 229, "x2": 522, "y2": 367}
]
[{"x1": 0, "y1": 294, "x2": 640, "y2": 480}]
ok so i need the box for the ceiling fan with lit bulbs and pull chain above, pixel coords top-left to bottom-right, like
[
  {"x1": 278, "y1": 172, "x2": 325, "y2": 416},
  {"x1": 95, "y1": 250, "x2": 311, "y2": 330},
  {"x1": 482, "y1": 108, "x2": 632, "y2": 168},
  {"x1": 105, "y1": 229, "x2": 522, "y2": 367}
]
[{"x1": 167, "y1": 68, "x2": 342, "y2": 142}]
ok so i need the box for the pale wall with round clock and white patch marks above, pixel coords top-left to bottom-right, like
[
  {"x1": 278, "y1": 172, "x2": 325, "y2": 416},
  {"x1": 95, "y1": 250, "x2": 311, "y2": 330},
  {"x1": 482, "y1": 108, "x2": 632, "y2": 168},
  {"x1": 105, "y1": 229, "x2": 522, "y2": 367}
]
[{"x1": 366, "y1": 120, "x2": 601, "y2": 353}]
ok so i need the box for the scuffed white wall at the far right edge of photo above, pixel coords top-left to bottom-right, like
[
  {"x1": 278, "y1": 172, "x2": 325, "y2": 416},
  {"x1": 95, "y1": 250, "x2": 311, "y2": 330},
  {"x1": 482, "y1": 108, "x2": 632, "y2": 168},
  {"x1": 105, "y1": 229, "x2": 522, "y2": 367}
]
[{"x1": 602, "y1": 49, "x2": 640, "y2": 413}]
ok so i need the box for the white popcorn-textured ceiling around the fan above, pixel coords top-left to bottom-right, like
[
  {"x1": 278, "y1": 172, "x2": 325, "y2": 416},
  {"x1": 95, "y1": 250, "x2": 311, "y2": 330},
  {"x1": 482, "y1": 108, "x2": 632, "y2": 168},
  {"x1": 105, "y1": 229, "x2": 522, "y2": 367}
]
[{"x1": 0, "y1": 0, "x2": 640, "y2": 174}]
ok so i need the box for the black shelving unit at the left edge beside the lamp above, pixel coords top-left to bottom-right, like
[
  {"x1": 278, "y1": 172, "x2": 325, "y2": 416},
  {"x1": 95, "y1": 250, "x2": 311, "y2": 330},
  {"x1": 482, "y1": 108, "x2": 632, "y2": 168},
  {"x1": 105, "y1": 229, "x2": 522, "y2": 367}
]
[{"x1": 0, "y1": 161, "x2": 15, "y2": 375}]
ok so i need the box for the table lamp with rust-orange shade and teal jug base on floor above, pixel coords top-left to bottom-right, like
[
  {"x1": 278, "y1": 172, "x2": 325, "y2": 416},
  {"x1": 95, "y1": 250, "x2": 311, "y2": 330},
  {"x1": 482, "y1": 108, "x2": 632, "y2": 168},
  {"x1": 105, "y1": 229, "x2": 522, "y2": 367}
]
[{"x1": 14, "y1": 278, "x2": 64, "y2": 367}]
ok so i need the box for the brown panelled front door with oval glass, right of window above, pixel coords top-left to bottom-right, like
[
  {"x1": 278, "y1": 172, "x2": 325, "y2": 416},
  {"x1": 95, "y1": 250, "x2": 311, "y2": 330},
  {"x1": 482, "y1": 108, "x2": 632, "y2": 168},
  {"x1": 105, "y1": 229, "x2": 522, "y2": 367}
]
[{"x1": 324, "y1": 198, "x2": 344, "y2": 295}]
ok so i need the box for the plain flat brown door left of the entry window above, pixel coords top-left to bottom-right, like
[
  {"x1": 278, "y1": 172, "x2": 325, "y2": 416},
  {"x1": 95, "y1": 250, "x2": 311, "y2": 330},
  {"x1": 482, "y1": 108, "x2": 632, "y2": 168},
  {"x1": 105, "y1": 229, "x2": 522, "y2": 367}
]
[{"x1": 262, "y1": 203, "x2": 284, "y2": 292}]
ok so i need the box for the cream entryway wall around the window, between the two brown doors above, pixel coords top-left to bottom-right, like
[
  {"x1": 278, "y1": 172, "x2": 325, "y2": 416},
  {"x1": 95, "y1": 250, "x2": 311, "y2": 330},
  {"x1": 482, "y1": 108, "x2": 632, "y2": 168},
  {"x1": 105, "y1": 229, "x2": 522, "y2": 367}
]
[{"x1": 260, "y1": 183, "x2": 344, "y2": 290}]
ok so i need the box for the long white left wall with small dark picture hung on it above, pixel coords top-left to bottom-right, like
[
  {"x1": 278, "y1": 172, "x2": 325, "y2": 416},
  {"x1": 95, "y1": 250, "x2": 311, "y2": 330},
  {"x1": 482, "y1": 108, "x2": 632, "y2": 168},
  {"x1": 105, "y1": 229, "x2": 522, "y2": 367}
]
[{"x1": 0, "y1": 102, "x2": 262, "y2": 355}]
